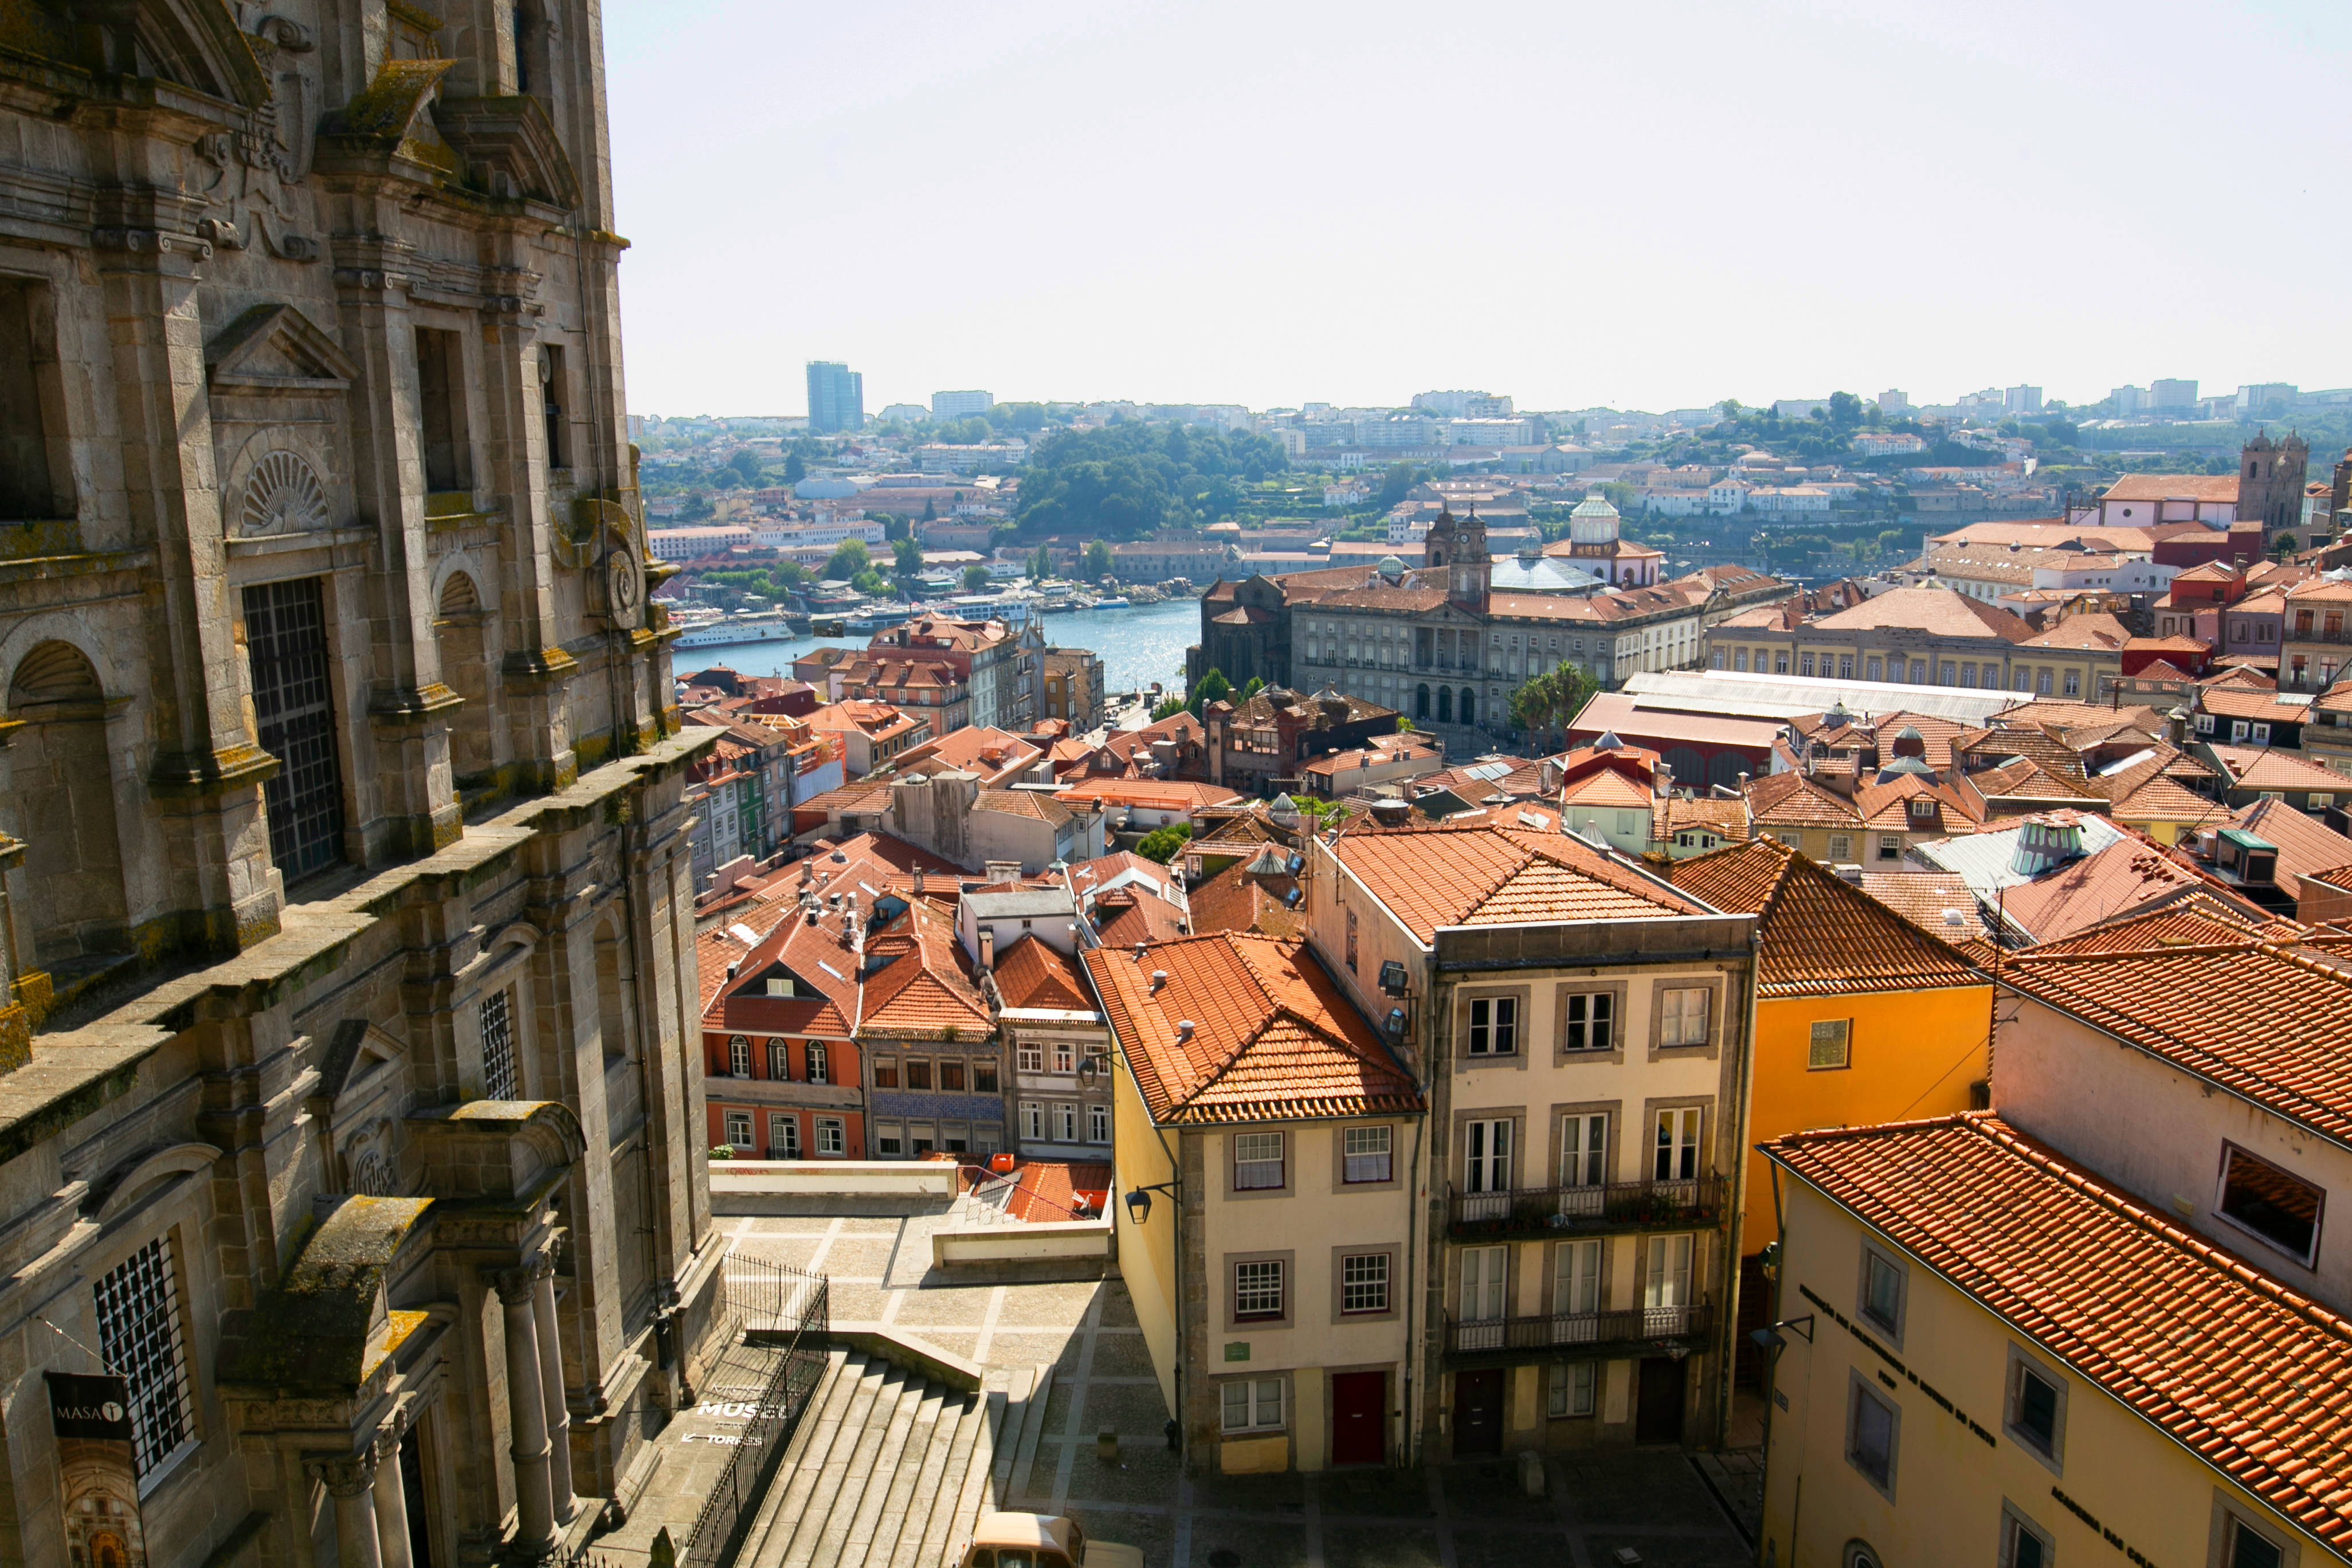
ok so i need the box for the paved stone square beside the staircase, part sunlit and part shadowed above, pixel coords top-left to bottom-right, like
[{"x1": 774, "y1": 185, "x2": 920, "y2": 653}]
[{"x1": 656, "y1": 1218, "x2": 1752, "y2": 1568}]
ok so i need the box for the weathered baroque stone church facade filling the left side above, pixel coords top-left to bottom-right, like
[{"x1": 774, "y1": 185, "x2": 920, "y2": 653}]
[{"x1": 0, "y1": 0, "x2": 722, "y2": 1568}]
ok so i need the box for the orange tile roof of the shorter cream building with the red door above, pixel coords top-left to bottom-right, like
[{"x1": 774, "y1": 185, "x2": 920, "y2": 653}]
[{"x1": 1087, "y1": 931, "x2": 1423, "y2": 1124}]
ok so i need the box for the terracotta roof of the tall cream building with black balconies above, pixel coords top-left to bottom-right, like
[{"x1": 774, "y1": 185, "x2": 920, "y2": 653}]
[{"x1": 1331, "y1": 825, "x2": 1705, "y2": 945}]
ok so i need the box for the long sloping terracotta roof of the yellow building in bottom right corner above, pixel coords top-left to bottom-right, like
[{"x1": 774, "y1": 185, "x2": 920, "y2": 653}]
[{"x1": 1764, "y1": 1112, "x2": 2352, "y2": 1551}]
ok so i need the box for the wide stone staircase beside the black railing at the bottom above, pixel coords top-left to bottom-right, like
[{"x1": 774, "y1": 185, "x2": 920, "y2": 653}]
[{"x1": 736, "y1": 1350, "x2": 1054, "y2": 1568}]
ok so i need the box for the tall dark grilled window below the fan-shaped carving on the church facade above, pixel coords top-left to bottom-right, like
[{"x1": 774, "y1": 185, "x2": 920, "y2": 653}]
[{"x1": 245, "y1": 578, "x2": 343, "y2": 881}]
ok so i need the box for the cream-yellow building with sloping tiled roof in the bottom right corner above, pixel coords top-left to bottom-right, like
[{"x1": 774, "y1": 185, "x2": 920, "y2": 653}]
[{"x1": 1757, "y1": 1114, "x2": 2323, "y2": 1568}]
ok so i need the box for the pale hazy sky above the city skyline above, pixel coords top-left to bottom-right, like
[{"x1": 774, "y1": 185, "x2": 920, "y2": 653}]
[{"x1": 605, "y1": 0, "x2": 2352, "y2": 414}]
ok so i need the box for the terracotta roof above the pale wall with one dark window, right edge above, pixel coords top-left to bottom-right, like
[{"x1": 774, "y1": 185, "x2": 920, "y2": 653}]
[{"x1": 2002, "y1": 940, "x2": 2352, "y2": 1145}]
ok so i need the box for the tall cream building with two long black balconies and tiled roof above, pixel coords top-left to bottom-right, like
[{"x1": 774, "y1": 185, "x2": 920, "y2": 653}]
[{"x1": 1306, "y1": 828, "x2": 1755, "y2": 1460}]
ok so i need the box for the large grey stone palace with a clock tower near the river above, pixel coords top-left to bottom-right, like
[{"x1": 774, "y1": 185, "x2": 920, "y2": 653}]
[{"x1": 1185, "y1": 501, "x2": 1790, "y2": 743}]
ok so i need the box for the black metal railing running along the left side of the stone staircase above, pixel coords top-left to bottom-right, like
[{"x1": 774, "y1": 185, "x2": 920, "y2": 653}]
[{"x1": 680, "y1": 1258, "x2": 830, "y2": 1568}]
